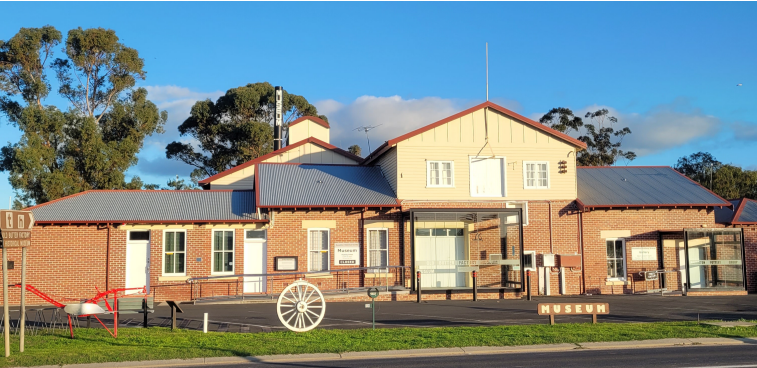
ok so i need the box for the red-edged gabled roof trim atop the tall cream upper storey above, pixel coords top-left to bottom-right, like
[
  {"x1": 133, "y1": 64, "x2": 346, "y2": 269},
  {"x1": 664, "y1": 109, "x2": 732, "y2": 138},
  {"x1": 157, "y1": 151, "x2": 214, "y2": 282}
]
[{"x1": 363, "y1": 101, "x2": 586, "y2": 164}]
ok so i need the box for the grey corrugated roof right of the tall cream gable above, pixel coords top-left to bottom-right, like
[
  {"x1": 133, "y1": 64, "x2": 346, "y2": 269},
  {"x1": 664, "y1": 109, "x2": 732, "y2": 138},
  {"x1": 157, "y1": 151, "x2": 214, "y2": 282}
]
[{"x1": 577, "y1": 166, "x2": 730, "y2": 206}]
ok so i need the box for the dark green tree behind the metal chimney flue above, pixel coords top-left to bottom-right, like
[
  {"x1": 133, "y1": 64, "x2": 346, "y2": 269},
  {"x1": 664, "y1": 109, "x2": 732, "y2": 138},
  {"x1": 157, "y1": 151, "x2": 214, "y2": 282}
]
[{"x1": 166, "y1": 82, "x2": 327, "y2": 181}]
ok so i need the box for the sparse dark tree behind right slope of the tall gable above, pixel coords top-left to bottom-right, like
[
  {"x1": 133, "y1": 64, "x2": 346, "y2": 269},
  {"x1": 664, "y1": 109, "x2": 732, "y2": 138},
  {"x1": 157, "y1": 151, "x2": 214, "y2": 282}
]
[{"x1": 539, "y1": 107, "x2": 636, "y2": 166}]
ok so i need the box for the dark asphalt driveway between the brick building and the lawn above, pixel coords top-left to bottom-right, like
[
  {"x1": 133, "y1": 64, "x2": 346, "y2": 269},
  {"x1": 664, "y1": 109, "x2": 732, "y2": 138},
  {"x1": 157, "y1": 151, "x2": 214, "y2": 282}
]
[{"x1": 97, "y1": 295, "x2": 757, "y2": 332}]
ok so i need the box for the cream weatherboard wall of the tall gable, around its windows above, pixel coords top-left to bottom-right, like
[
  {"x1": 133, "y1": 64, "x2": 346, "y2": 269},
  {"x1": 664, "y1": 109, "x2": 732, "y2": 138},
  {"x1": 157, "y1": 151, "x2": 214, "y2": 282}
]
[{"x1": 376, "y1": 108, "x2": 578, "y2": 201}]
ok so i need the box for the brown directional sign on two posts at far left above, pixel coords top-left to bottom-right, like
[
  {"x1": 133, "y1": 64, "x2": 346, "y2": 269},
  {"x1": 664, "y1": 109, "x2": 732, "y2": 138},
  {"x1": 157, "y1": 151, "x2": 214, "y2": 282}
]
[{"x1": 0, "y1": 210, "x2": 34, "y2": 357}]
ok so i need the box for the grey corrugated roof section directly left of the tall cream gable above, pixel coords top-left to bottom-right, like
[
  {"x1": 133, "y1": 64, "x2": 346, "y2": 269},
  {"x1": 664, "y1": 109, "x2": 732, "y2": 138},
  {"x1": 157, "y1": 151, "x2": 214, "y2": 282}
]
[{"x1": 256, "y1": 164, "x2": 397, "y2": 207}]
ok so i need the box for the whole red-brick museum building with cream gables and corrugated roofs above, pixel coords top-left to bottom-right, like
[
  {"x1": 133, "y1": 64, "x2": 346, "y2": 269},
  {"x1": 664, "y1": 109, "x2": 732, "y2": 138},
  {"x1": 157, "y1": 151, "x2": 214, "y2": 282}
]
[{"x1": 4, "y1": 102, "x2": 757, "y2": 300}]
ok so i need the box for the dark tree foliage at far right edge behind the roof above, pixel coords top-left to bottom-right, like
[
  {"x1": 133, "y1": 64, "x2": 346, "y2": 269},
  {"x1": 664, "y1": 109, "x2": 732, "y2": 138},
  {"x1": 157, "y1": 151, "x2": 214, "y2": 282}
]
[{"x1": 674, "y1": 152, "x2": 757, "y2": 199}]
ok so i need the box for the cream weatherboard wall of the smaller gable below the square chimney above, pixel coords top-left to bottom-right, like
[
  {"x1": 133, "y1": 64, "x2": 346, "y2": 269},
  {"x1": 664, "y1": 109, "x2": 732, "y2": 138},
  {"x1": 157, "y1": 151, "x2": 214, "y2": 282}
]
[{"x1": 209, "y1": 139, "x2": 358, "y2": 190}]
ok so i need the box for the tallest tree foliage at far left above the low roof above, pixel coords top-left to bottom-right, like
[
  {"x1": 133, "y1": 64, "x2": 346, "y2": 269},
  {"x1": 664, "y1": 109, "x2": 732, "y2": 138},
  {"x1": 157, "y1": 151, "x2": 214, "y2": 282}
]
[{"x1": 0, "y1": 26, "x2": 167, "y2": 205}]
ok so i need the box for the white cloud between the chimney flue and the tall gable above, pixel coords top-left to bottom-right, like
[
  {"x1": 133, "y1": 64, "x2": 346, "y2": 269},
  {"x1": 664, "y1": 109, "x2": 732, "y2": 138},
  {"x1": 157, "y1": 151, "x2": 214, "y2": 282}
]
[{"x1": 314, "y1": 96, "x2": 520, "y2": 155}]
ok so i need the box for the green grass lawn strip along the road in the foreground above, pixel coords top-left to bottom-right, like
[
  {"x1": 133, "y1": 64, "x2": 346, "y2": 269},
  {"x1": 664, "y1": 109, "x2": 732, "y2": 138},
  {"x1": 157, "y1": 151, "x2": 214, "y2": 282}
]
[{"x1": 0, "y1": 322, "x2": 757, "y2": 367}]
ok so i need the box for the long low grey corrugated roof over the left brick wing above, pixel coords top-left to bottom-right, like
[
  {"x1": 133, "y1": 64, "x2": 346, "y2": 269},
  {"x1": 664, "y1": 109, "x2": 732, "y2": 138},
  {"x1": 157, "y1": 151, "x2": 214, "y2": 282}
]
[{"x1": 31, "y1": 190, "x2": 255, "y2": 223}]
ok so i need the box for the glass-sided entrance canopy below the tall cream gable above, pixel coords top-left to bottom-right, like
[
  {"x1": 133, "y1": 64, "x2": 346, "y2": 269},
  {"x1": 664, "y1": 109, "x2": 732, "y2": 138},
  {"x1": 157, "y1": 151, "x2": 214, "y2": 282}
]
[{"x1": 410, "y1": 209, "x2": 534, "y2": 289}]
